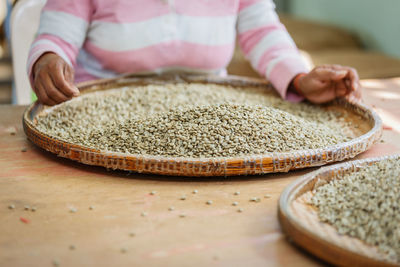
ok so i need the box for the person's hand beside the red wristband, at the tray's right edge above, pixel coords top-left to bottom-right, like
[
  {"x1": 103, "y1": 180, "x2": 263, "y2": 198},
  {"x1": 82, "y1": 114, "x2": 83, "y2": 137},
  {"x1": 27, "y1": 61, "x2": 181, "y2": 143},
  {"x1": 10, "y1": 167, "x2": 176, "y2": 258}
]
[{"x1": 293, "y1": 65, "x2": 361, "y2": 104}]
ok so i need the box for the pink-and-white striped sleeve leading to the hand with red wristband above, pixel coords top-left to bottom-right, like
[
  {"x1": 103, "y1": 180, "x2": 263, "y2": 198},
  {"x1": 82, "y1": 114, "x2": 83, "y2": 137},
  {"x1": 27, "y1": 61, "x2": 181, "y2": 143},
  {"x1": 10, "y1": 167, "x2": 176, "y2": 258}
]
[{"x1": 237, "y1": 0, "x2": 309, "y2": 101}]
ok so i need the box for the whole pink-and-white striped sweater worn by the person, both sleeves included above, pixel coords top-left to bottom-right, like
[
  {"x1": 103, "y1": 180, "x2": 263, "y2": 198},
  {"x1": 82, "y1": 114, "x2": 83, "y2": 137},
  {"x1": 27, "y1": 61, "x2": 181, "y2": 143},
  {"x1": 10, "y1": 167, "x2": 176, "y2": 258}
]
[{"x1": 28, "y1": 0, "x2": 308, "y2": 101}]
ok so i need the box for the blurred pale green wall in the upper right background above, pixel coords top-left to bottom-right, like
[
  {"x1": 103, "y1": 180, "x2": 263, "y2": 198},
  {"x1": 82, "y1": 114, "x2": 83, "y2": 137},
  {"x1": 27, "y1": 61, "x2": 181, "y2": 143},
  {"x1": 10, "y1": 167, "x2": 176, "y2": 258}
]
[{"x1": 275, "y1": 0, "x2": 400, "y2": 58}]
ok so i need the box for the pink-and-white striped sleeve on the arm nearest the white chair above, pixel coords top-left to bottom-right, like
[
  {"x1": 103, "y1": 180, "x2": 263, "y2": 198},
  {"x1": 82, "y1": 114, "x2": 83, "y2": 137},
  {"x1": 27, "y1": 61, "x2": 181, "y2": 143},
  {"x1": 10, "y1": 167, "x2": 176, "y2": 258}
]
[{"x1": 27, "y1": 0, "x2": 92, "y2": 85}]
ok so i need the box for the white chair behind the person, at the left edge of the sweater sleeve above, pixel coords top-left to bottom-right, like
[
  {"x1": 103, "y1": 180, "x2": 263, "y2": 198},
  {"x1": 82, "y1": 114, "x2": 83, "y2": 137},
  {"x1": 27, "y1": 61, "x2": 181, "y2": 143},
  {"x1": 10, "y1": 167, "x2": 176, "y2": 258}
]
[{"x1": 11, "y1": 0, "x2": 46, "y2": 105}]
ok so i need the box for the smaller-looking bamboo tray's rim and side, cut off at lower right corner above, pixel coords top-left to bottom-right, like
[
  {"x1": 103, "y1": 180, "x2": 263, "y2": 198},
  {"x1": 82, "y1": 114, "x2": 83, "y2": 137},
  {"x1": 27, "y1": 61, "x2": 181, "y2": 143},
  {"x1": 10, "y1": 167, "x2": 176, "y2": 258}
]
[{"x1": 278, "y1": 155, "x2": 400, "y2": 266}]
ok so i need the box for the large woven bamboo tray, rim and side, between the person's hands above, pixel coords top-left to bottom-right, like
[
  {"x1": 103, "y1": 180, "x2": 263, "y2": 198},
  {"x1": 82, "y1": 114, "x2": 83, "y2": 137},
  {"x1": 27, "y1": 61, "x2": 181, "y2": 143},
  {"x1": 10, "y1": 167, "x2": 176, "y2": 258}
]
[{"x1": 23, "y1": 75, "x2": 382, "y2": 176}]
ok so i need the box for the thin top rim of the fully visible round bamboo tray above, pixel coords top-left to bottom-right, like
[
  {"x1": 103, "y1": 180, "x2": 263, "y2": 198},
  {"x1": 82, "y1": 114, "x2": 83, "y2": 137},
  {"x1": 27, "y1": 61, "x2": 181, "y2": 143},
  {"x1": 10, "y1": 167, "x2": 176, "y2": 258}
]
[{"x1": 23, "y1": 74, "x2": 382, "y2": 177}]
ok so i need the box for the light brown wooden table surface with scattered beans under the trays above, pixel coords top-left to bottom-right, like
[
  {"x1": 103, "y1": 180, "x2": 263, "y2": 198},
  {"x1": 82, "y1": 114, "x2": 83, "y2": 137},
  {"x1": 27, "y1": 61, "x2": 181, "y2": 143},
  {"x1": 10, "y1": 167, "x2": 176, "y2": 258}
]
[{"x1": 0, "y1": 78, "x2": 400, "y2": 266}]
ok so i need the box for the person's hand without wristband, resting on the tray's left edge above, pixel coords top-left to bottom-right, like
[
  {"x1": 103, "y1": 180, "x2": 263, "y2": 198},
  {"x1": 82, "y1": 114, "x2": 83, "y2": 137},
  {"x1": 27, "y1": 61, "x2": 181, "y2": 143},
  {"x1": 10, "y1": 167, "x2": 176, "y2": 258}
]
[{"x1": 33, "y1": 53, "x2": 79, "y2": 106}]
